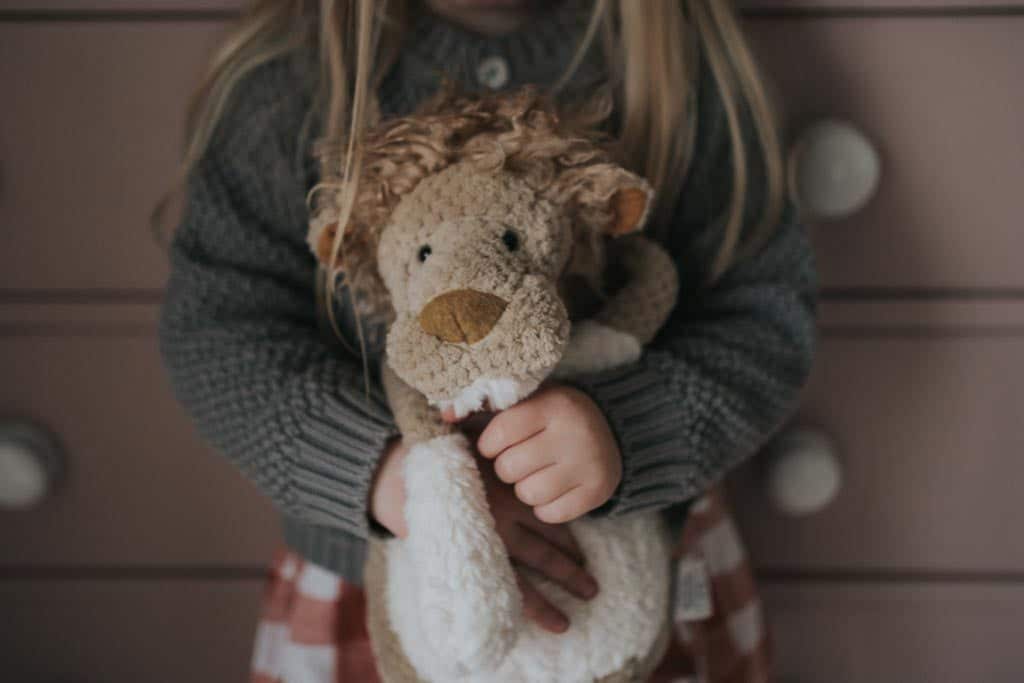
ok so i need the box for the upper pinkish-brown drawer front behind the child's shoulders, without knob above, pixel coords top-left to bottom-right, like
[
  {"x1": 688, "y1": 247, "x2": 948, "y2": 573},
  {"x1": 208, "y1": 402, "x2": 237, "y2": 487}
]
[{"x1": 0, "y1": 16, "x2": 1024, "y2": 290}]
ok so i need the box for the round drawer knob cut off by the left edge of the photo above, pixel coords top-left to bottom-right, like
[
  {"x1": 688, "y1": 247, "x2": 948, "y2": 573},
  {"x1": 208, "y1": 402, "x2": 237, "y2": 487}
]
[{"x1": 0, "y1": 421, "x2": 60, "y2": 509}]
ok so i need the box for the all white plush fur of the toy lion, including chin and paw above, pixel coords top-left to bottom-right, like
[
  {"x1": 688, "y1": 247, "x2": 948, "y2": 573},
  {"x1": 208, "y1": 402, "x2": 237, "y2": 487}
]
[{"x1": 387, "y1": 323, "x2": 671, "y2": 683}]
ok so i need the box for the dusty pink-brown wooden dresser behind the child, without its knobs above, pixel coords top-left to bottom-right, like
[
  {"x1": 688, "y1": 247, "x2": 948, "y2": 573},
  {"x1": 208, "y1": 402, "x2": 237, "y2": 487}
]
[{"x1": 0, "y1": 0, "x2": 1024, "y2": 683}]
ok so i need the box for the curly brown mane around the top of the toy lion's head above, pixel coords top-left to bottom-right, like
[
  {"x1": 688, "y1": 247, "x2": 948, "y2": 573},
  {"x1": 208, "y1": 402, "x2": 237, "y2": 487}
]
[{"x1": 309, "y1": 86, "x2": 643, "y2": 321}]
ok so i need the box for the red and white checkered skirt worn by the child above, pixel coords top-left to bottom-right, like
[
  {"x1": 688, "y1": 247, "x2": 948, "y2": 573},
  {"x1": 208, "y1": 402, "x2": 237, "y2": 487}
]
[{"x1": 251, "y1": 490, "x2": 770, "y2": 683}]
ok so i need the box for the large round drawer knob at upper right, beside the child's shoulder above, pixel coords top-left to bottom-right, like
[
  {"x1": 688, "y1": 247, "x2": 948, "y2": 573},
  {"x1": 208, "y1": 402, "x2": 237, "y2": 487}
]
[{"x1": 788, "y1": 120, "x2": 882, "y2": 220}]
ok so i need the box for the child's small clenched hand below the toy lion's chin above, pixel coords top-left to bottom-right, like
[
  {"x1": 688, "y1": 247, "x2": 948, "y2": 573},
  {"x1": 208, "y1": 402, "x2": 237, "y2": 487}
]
[{"x1": 477, "y1": 385, "x2": 623, "y2": 524}]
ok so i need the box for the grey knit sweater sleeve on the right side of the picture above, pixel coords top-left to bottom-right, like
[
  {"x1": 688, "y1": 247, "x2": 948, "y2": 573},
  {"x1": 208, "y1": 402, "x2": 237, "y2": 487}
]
[{"x1": 577, "y1": 70, "x2": 816, "y2": 514}]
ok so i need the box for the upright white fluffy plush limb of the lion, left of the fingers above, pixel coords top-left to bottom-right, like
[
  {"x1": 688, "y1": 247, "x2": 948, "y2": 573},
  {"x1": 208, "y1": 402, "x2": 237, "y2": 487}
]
[{"x1": 387, "y1": 434, "x2": 522, "y2": 681}]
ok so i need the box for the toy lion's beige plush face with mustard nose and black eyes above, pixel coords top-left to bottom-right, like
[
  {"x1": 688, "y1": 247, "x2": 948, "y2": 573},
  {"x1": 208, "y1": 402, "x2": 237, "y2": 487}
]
[{"x1": 378, "y1": 164, "x2": 572, "y2": 417}]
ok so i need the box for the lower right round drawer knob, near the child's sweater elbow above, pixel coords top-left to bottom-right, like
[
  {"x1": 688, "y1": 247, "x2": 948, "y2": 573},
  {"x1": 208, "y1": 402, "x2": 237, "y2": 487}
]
[{"x1": 766, "y1": 427, "x2": 843, "y2": 515}]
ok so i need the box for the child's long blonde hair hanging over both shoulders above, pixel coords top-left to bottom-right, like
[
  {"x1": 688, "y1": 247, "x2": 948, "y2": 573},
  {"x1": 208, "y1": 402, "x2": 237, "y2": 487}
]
[{"x1": 182, "y1": 0, "x2": 785, "y2": 279}]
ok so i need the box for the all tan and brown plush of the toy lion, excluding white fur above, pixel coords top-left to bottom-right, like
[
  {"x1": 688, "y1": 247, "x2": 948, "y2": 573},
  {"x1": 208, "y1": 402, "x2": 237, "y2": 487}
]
[{"x1": 309, "y1": 89, "x2": 677, "y2": 683}]
